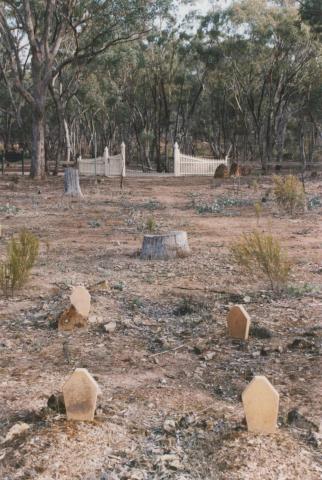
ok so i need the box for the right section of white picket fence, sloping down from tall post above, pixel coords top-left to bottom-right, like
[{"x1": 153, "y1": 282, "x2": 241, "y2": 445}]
[{"x1": 174, "y1": 143, "x2": 229, "y2": 177}]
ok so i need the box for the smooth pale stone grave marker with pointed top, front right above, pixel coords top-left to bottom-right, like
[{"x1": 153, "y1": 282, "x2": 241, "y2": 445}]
[{"x1": 242, "y1": 376, "x2": 279, "y2": 434}]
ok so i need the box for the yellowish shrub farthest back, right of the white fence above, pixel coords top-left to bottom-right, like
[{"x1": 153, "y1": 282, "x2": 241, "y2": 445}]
[{"x1": 274, "y1": 175, "x2": 305, "y2": 215}]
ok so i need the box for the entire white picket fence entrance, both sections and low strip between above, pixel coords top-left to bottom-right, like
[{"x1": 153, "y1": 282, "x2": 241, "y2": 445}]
[{"x1": 78, "y1": 143, "x2": 229, "y2": 177}]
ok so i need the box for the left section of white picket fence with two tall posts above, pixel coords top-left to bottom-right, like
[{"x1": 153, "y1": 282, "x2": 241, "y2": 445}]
[{"x1": 78, "y1": 143, "x2": 126, "y2": 177}]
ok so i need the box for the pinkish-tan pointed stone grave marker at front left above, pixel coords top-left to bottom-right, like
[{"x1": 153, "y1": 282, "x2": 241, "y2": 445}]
[{"x1": 63, "y1": 368, "x2": 100, "y2": 421}]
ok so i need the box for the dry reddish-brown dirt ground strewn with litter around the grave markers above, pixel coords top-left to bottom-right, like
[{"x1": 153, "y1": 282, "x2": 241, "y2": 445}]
[{"x1": 0, "y1": 173, "x2": 322, "y2": 480}]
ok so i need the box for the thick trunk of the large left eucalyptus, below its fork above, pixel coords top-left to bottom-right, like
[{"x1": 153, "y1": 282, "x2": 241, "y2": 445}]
[{"x1": 30, "y1": 112, "x2": 45, "y2": 178}]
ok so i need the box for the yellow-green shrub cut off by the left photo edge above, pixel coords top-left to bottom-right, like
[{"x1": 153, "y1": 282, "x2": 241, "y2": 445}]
[{"x1": 0, "y1": 228, "x2": 39, "y2": 296}]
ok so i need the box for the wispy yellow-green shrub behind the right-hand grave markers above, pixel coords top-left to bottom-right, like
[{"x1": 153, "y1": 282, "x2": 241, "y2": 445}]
[{"x1": 231, "y1": 230, "x2": 291, "y2": 290}]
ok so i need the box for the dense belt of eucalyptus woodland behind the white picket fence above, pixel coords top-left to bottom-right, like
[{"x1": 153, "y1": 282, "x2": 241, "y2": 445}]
[{"x1": 0, "y1": 0, "x2": 322, "y2": 177}]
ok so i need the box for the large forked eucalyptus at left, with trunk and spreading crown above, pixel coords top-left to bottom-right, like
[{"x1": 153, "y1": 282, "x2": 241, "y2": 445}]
[{"x1": 0, "y1": 0, "x2": 163, "y2": 177}]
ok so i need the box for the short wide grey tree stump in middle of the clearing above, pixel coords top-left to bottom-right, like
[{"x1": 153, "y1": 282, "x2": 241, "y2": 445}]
[{"x1": 141, "y1": 232, "x2": 190, "y2": 260}]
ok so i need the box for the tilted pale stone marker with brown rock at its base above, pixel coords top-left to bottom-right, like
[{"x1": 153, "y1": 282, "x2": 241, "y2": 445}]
[{"x1": 58, "y1": 286, "x2": 91, "y2": 331}]
